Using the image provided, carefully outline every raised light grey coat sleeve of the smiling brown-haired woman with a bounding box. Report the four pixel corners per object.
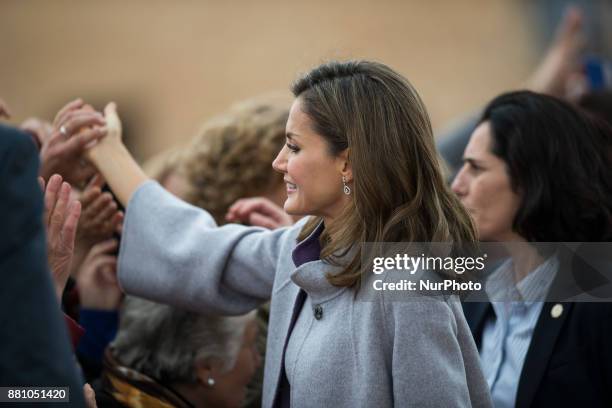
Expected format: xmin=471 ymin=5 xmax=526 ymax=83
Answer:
xmin=119 ymin=181 xmax=298 ymax=315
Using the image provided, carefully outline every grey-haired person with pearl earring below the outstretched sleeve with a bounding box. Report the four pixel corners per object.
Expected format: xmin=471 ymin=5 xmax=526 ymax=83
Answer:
xmin=96 ymin=297 xmax=261 ymax=408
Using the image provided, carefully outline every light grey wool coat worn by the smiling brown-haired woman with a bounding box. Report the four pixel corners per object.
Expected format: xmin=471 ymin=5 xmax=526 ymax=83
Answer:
xmin=119 ymin=181 xmax=491 ymax=408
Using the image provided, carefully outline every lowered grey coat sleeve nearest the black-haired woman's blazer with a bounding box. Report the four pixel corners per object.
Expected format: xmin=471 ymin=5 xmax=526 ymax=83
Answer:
xmin=385 ymin=297 xmax=491 ymax=407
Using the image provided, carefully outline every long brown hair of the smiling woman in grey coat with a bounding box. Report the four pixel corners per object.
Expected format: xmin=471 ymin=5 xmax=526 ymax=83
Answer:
xmin=292 ymin=61 xmax=477 ymax=287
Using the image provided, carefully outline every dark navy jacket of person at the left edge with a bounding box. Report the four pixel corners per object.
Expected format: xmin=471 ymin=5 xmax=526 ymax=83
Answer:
xmin=0 ymin=125 xmax=85 ymax=406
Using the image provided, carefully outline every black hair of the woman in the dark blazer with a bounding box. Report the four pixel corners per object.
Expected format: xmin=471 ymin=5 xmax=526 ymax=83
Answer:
xmin=479 ymin=91 xmax=612 ymax=242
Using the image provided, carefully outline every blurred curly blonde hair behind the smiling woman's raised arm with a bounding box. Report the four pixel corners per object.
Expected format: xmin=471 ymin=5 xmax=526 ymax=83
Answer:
xmin=177 ymin=100 xmax=289 ymax=225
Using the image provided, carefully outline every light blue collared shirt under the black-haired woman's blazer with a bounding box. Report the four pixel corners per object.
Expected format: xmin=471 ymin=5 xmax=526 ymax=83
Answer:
xmin=480 ymin=257 xmax=558 ymax=408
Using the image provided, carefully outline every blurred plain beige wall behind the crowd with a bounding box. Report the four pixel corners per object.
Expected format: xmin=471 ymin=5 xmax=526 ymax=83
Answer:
xmin=0 ymin=0 xmax=533 ymax=158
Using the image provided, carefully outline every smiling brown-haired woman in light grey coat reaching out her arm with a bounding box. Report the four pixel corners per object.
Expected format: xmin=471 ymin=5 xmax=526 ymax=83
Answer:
xmin=82 ymin=61 xmax=490 ymax=407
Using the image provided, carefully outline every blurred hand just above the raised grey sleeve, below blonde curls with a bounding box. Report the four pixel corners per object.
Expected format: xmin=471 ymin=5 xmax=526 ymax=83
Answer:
xmin=225 ymin=197 xmax=293 ymax=229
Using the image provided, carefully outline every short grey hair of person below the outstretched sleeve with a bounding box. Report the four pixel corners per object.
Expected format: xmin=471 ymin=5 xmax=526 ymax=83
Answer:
xmin=111 ymin=297 xmax=254 ymax=383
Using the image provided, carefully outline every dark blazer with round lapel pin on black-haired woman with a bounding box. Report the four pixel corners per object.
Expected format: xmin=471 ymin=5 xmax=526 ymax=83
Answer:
xmin=463 ymin=249 xmax=612 ymax=408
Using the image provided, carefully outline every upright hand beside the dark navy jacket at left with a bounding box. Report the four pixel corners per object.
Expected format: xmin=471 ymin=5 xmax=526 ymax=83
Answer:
xmin=39 ymin=174 xmax=81 ymax=299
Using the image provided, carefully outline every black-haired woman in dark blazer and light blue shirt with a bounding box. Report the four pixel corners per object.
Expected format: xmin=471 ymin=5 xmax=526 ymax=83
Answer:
xmin=452 ymin=92 xmax=612 ymax=407
